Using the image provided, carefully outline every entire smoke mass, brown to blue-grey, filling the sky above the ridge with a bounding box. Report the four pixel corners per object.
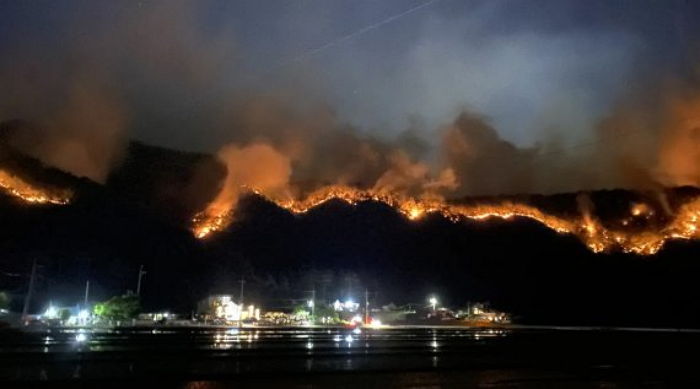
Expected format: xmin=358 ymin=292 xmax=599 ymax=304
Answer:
xmin=0 ymin=1 xmax=700 ymax=203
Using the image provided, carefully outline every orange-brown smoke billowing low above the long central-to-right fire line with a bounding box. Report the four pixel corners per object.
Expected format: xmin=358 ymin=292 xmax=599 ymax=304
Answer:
xmin=206 ymin=80 xmax=700 ymax=218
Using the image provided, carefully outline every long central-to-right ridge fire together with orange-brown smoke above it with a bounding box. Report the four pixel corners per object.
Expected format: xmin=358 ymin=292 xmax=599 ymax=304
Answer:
xmin=186 ymin=90 xmax=700 ymax=255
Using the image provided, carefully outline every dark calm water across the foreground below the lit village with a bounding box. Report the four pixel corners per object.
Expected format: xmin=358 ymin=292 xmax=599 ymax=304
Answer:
xmin=0 ymin=328 xmax=700 ymax=388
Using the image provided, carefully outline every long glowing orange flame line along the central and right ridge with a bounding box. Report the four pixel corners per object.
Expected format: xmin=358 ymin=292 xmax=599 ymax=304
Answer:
xmin=193 ymin=186 xmax=700 ymax=255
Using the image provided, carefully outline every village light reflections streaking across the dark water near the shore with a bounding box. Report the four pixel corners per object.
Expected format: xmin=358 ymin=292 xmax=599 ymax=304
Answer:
xmin=0 ymin=327 xmax=509 ymax=379
